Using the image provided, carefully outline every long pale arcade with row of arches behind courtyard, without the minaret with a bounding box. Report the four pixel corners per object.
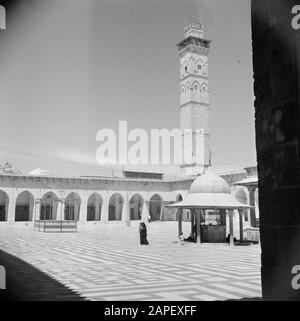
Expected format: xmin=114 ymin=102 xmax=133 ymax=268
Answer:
xmin=0 ymin=170 xmax=258 ymax=235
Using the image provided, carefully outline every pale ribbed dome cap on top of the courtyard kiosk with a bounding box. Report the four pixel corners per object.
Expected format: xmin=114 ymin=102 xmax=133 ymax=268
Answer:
xmin=190 ymin=168 xmax=231 ymax=194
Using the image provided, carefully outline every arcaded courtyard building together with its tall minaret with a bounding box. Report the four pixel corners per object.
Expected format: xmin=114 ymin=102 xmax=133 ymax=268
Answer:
xmin=0 ymin=22 xmax=257 ymax=235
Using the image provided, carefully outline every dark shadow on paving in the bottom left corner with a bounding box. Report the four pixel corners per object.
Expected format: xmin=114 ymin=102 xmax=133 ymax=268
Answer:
xmin=0 ymin=250 xmax=85 ymax=301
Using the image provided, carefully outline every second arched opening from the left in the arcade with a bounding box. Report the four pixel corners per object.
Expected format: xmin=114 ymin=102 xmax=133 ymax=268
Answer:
xmin=15 ymin=191 xmax=34 ymax=222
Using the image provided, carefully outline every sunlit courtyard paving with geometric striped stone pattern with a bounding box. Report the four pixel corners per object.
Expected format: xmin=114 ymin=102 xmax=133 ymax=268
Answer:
xmin=0 ymin=222 xmax=261 ymax=301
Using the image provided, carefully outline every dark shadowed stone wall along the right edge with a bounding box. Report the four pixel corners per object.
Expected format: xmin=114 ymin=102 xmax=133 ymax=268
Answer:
xmin=252 ymin=0 xmax=300 ymax=300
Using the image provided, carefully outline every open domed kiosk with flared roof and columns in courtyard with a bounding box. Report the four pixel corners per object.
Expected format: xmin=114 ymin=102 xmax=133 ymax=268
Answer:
xmin=169 ymin=168 xmax=251 ymax=245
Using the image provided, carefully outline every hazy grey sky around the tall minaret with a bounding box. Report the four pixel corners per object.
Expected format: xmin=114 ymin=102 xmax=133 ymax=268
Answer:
xmin=0 ymin=0 xmax=256 ymax=176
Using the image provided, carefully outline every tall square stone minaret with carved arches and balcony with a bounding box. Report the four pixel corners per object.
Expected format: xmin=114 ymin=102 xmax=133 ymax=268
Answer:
xmin=177 ymin=21 xmax=210 ymax=175
